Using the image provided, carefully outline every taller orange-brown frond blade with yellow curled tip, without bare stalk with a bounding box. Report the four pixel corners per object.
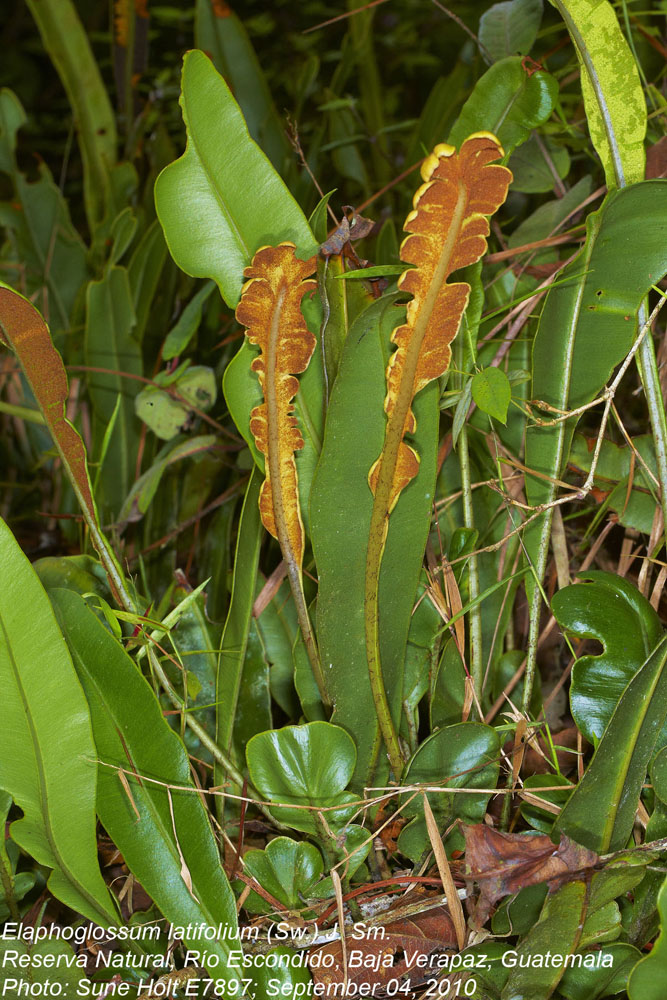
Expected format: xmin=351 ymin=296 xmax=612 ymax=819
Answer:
xmin=369 ymin=132 xmax=512 ymax=512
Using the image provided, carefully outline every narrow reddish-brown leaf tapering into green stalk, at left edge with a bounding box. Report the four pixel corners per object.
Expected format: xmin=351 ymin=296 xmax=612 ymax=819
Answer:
xmin=0 ymin=284 xmax=132 ymax=610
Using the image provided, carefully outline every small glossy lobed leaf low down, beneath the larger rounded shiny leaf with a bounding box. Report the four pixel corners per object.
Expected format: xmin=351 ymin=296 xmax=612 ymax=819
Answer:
xmin=243 ymin=837 xmax=324 ymax=913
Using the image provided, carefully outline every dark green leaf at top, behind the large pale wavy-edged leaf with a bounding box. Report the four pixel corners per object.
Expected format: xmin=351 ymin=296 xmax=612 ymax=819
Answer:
xmin=195 ymin=0 xmax=291 ymax=172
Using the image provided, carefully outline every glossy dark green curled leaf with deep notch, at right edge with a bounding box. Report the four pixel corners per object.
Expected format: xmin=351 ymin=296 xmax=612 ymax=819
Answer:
xmin=551 ymin=570 xmax=662 ymax=743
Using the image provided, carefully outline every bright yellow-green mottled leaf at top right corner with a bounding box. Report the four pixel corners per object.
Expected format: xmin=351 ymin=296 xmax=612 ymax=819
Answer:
xmin=551 ymin=0 xmax=646 ymax=189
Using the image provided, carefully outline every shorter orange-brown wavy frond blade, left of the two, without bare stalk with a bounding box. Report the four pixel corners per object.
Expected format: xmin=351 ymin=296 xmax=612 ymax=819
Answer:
xmin=236 ymin=243 xmax=317 ymax=567
